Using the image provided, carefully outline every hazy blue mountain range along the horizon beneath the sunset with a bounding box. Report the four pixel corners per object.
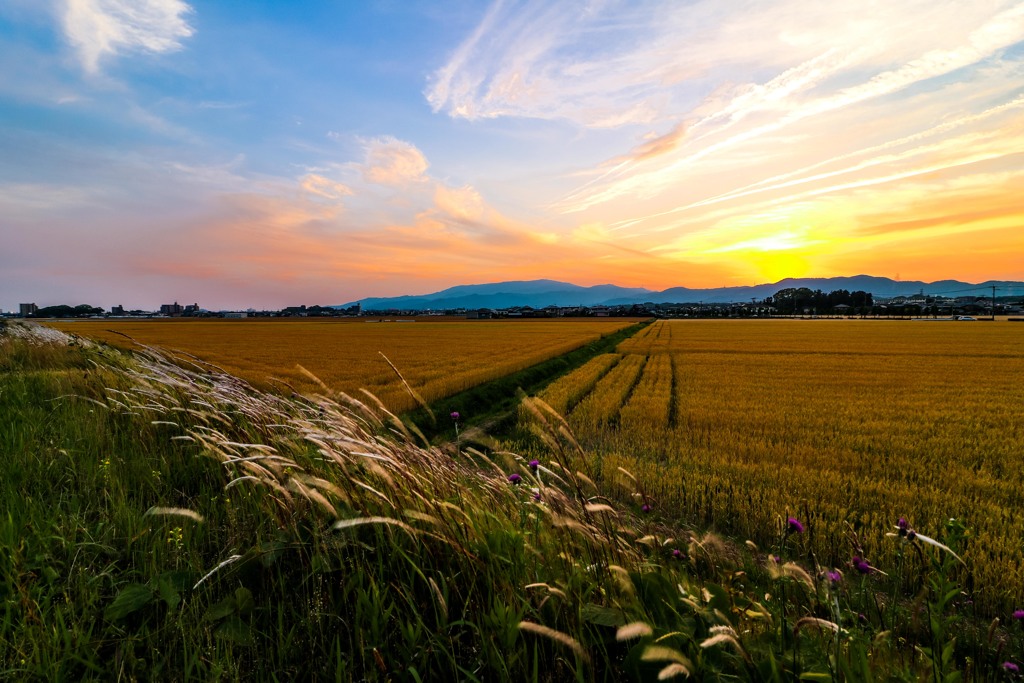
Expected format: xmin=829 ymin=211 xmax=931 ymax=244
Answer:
xmin=335 ymin=275 xmax=1024 ymax=310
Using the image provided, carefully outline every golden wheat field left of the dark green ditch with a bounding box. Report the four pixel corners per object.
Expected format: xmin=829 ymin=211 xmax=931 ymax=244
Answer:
xmin=52 ymin=318 xmax=636 ymax=412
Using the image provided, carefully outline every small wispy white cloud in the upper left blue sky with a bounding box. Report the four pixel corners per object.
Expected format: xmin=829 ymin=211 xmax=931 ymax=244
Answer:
xmin=61 ymin=0 xmax=195 ymax=74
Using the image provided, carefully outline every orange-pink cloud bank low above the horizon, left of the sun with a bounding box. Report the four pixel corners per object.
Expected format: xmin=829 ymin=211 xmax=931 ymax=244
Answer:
xmin=116 ymin=169 xmax=749 ymax=305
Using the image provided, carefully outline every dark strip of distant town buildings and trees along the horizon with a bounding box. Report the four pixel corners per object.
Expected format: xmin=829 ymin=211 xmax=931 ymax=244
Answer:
xmin=8 ymin=288 xmax=1024 ymax=319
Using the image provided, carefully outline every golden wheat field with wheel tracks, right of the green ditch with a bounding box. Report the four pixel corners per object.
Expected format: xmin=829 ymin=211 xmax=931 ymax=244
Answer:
xmin=541 ymin=321 xmax=1024 ymax=607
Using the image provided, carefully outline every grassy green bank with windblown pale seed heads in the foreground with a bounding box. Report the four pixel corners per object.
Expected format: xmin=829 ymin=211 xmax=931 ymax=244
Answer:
xmin=0 ymin=326 xmax=1024 ymax=681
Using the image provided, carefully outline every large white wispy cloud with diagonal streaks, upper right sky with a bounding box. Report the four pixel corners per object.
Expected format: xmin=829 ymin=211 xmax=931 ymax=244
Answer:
xmin=427 ymin=0 xmax=1024 ymax=224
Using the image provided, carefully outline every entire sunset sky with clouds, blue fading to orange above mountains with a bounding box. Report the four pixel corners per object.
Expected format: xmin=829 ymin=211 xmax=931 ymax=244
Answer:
xmin=0 ymin=0 xmax=1024 ymax=310
